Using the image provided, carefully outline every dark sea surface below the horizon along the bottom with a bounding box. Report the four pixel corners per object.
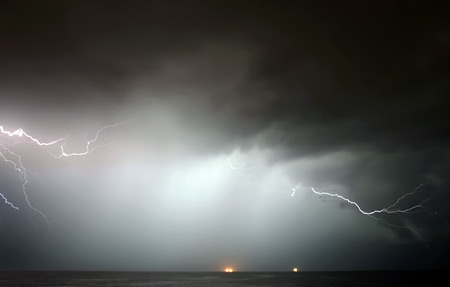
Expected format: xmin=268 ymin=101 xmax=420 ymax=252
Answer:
xmin=0 ymin=271 xmax=442 ymax=287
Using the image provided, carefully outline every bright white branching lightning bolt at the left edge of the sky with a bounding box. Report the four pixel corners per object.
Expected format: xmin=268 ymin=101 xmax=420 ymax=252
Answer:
xmin=0 ymin=120 xmax=129 ymax=226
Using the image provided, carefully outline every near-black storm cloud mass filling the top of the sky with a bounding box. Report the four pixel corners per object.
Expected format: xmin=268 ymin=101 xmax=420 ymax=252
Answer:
xmin=2 ymin=1 xmax=449 ymax=149
